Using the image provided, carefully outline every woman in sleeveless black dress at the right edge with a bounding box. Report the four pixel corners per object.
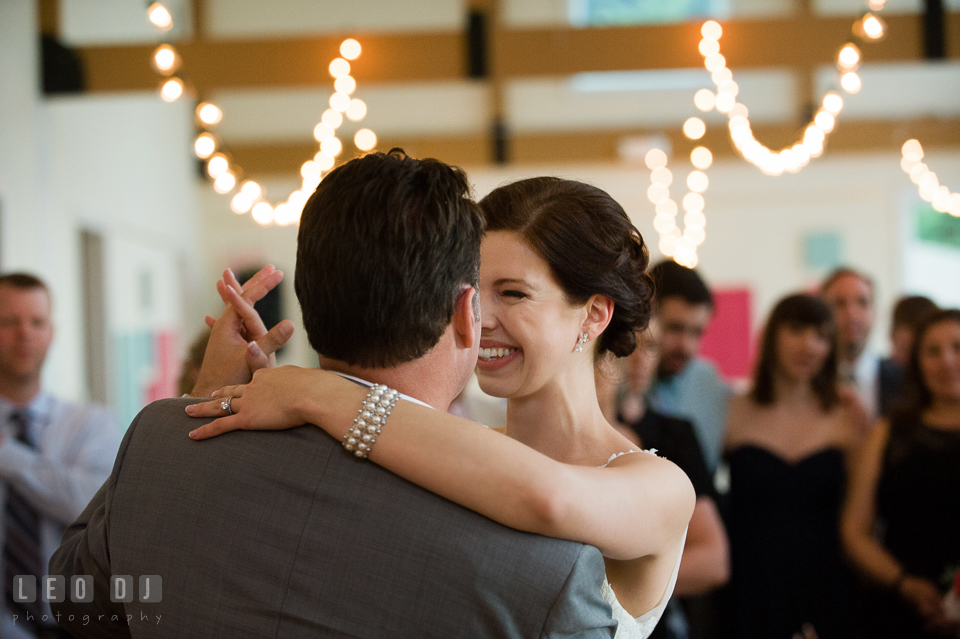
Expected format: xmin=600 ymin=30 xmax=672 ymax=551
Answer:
xmin=843 ymin=309 xmax=960 ymax=639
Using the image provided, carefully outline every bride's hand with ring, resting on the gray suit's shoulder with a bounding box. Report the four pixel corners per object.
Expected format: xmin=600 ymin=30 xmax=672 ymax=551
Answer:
xmin=186 ymin=366 xmax=324 ymax=440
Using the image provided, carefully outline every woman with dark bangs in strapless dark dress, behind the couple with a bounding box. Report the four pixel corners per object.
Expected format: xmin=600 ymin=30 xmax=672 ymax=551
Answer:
xmin=726 ymin=295 xmax=856 ymax=639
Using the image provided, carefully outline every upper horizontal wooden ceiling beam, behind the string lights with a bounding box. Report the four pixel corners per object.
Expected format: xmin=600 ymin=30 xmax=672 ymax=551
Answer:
xmin=79 ymin=12 xmax=960 ymax=94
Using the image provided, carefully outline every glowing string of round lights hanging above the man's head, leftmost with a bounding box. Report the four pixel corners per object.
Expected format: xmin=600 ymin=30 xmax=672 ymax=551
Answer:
xmin=147 ymin=2 xmax=377 ymax=226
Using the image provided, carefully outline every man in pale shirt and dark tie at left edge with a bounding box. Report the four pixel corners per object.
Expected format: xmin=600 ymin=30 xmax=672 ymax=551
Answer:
xmin=0 ymin=273 xmax=121 ymax=638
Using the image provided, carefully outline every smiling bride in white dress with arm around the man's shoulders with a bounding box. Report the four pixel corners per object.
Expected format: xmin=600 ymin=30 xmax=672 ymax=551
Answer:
xmin=187 ymin=178 xmax=694 ymax=639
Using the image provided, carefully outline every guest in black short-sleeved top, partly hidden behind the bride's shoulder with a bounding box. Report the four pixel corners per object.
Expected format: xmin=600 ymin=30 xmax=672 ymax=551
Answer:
xmin=597 ymin=318 xmax=730 ymax=639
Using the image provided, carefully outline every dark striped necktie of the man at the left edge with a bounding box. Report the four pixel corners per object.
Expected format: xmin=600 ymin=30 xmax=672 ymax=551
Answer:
xmin=3 ymin=412 xmax=44 ymax=620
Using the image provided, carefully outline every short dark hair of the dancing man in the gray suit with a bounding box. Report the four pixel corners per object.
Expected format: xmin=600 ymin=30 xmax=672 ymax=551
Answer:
xmin=294 ymin=149 xmax=484 ymax=368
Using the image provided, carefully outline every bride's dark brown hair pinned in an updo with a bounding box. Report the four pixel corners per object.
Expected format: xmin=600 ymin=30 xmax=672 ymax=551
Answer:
xmin=480 ymin=177 xmax=653 ymax=357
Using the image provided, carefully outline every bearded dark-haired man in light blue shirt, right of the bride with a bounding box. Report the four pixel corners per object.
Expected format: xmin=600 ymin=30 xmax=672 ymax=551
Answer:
xmin=647 ymin=260 xmax=730 ymax=473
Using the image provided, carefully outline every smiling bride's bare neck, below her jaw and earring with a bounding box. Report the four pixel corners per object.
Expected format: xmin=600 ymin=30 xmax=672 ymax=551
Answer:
xmin=506 ymin=370 xmax=609 ymax=461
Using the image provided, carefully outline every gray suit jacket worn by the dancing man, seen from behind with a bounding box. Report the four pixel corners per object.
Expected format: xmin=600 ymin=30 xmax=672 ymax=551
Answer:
xmin=50 ymin=400 xmax=616 ymax=639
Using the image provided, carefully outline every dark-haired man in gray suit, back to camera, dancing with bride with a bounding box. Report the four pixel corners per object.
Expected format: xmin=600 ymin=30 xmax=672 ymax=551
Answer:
xmin=50 ymin=151 xmax=616 ymax=638
